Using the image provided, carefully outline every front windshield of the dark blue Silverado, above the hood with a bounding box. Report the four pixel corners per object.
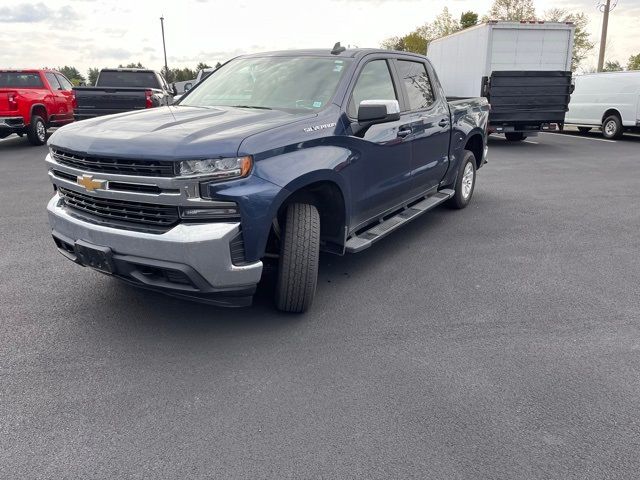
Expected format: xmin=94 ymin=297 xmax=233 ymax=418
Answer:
xmin=180 ymin=57 xmax=350 ymax=110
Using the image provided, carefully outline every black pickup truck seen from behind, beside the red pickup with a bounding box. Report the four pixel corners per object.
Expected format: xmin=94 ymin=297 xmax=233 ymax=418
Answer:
xmin=73 ymin=68 xmax=175 ymax=120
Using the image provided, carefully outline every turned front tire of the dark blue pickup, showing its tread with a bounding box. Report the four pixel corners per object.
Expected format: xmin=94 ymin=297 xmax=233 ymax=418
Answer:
xmin=276 ymin=203 xmax=320 ymax=313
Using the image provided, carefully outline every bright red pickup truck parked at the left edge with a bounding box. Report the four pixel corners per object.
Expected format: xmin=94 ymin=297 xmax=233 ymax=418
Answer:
xmin=0 ymin=70 xmax=75 ymax=145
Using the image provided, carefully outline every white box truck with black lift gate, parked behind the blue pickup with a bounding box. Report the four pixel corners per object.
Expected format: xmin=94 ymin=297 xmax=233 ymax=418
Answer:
xmin=427 ymin=21 xmax=575 ymax=141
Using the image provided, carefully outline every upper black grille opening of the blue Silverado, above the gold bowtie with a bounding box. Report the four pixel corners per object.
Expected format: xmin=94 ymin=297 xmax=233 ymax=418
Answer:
xmin=51 ymin=147 xmax=174 ymax=177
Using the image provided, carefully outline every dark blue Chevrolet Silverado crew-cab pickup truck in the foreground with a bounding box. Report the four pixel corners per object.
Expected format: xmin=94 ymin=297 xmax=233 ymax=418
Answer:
xmin=46 ymin=45 xmax=489 ymax=312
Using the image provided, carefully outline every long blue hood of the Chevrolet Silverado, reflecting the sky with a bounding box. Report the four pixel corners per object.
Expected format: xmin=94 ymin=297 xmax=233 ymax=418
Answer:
xmin=49 ymin=106 xmax=316 ymax=160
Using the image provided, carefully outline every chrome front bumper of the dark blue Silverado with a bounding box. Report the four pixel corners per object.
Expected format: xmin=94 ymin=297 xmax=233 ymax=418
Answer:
xmin=47 ymin=194 xmax=262 ymax=306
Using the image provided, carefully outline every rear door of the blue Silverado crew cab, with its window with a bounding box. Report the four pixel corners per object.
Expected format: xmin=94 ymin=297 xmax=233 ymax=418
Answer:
xmin=395 ymin=59 xmax=451 ymax=194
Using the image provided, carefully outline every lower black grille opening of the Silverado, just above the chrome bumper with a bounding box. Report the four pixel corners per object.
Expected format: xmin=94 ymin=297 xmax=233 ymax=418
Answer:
xmin=58 ymin=187 xmax=180 ymax=229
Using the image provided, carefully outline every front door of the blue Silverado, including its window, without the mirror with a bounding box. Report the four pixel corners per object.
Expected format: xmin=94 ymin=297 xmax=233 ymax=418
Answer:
xmin=347 ymin=58 xmax=411 ymax=228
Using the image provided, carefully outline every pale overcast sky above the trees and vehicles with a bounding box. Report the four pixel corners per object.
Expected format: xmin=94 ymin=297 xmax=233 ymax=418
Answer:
xmin=0 ymin=0 xmax=640 ymax=74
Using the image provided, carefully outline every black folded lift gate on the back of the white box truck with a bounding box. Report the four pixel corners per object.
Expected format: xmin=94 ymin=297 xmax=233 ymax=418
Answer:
xmin=488 ymin=71 xmax=571 ymax=123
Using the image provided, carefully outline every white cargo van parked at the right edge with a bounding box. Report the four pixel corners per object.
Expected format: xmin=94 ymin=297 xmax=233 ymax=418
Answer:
xmin=566 ymin=70 xmax=640 ymax=138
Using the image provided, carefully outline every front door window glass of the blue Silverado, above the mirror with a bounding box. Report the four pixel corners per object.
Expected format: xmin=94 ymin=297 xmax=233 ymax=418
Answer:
xmin=347 ymin=60 xmax=398 ymax=118
